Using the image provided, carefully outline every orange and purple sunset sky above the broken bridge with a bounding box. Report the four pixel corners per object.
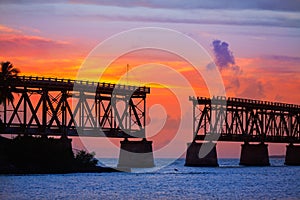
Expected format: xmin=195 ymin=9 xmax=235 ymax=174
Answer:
xmin=0 ymin=0 xmax=300 ymax=159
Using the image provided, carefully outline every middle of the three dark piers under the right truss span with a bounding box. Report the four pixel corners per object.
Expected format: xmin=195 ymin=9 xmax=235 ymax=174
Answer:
xmin=240 ymin=143 xmax=270 ymax=166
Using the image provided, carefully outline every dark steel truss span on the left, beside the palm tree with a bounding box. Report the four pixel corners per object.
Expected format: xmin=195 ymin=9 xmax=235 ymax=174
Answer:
xmin=0 ymin=76 xmax=150 ymax=138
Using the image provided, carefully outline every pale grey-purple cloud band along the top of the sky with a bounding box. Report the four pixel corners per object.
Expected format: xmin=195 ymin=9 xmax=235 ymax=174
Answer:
xmin=0 ymin=0 xmax=300 ymax=28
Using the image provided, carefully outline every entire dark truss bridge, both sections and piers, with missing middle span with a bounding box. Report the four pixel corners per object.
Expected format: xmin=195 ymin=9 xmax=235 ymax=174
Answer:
xmin=0 ymin=76 xmax=300 ymax=166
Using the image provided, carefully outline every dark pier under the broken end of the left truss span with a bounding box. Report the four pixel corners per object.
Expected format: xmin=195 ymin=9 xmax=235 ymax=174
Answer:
xmin=118 ymin=139 xmax=154 ymax=168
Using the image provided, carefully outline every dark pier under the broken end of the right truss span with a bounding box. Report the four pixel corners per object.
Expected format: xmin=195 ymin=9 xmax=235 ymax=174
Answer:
xmin=185 ymin=142 xmax=219 ymax=167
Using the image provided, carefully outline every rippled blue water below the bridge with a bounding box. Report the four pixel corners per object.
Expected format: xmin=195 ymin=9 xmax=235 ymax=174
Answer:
xmin=0 ymin=159 xmax=300 ymax=199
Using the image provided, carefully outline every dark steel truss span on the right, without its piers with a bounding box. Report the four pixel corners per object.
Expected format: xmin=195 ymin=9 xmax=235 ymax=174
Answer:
xmin=189 ymin=97 xmax=300 ymax=143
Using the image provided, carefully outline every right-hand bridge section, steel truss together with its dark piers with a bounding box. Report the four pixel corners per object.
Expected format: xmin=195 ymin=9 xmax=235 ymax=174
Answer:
xmin=186 ymin=97 xmax=300 ymax=166
